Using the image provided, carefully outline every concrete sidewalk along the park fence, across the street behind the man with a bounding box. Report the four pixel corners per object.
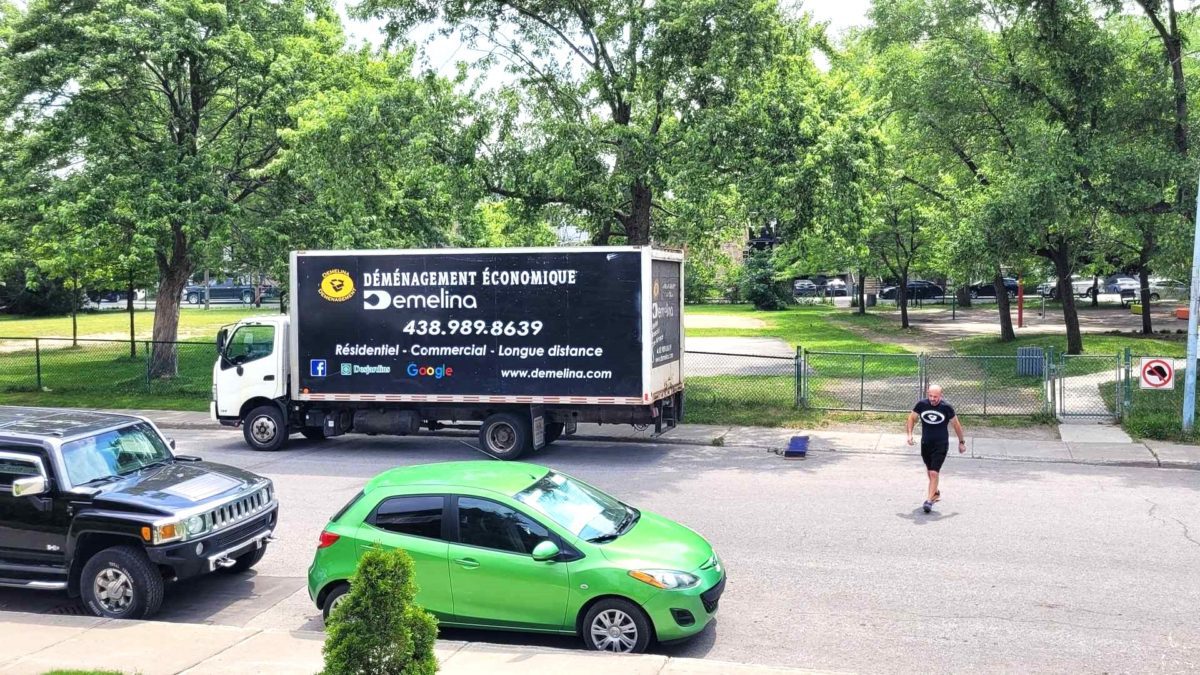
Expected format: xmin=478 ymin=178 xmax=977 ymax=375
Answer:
xmin=121 ymin=411 xmax=1200 ymax=470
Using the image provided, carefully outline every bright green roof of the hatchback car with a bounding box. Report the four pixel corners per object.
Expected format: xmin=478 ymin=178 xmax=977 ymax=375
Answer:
xmin=364 ymin=460 xmax=550 ymax=495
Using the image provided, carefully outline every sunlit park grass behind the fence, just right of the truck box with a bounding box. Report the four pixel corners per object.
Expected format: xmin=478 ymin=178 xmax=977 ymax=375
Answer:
xmin=684 ymin=300 xmax=908 ymax=354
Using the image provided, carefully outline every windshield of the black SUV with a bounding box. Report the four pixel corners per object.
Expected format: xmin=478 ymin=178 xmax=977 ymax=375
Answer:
xmin=62 ymin=423 xmax=172 ymax=485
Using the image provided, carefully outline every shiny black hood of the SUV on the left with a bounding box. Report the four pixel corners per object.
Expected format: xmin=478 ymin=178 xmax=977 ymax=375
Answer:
xmin=92 ymin=461 xmax=266 ymax=515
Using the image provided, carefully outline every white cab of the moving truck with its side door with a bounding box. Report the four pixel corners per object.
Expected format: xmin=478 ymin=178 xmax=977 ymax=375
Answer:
xmin=216 ymin=323 xmax=283 ymax=417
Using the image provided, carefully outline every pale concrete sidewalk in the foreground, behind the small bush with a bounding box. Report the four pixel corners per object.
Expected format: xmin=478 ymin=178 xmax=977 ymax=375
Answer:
xmin=0 ymin=611 xmax=812 ymax=675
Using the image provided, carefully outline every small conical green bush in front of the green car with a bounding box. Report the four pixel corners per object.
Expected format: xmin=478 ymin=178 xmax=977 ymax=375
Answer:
xmin=324 ymin=550 xmax=438 ymax=675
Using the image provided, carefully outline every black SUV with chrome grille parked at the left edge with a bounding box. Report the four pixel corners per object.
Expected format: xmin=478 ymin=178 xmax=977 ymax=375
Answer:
xmin=0 ymin=406 xmax=278 ymax=619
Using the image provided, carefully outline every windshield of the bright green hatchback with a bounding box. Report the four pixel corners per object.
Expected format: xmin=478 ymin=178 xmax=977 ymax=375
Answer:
xmin=514 ymin=471 xmax=636 ymax=539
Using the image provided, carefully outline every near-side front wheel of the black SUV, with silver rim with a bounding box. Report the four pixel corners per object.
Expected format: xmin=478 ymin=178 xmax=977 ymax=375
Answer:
xmin=79 ymin=545 xmax=163 ymax=619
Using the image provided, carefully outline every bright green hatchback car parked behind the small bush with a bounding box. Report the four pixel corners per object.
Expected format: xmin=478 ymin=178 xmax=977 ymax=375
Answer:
xmin=308 ymin=461 xmax=725 ymax=652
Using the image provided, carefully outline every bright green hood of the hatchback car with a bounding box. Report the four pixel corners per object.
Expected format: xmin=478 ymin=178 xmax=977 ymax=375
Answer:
xmin=598 ymin=510 xmax=713 ymax=572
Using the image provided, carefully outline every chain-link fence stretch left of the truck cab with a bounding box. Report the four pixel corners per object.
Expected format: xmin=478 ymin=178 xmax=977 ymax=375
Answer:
xmin=0 ymin=338 xmax=216 ymax=400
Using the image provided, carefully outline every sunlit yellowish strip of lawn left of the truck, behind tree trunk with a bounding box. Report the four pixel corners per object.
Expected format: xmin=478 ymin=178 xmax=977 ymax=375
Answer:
xmin=0 ymin=306 xmax=278 ymax=341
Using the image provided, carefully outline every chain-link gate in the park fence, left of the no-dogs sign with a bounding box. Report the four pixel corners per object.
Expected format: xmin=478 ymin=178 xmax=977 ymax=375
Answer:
xmin=1054 ymin=353 xmax=1126 ymax=419
